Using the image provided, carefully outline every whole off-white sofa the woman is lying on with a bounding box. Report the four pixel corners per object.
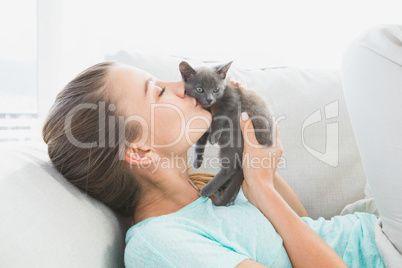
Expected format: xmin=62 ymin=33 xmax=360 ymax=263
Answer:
xmin=0 ymin=51 xmax=366 ymax=267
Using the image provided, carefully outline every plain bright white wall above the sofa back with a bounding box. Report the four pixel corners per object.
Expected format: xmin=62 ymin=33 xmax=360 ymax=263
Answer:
xmin=34 ymin=0 xmax=402 ymax=116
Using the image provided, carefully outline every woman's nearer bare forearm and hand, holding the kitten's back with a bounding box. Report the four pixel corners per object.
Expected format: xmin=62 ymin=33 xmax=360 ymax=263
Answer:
xmin=240 ymin=114 xmax=347 ymax=267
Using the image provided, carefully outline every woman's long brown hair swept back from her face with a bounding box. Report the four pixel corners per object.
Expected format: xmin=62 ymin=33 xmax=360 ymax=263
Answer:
xmin=42 ymin=62 xmax=214 ymax=217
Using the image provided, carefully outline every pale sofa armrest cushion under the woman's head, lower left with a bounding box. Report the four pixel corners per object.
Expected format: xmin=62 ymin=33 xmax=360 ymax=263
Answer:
xmin=0 ymin=144 xmax=131 ymax=267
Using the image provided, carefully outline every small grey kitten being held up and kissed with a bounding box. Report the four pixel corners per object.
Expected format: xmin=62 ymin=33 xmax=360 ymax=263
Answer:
xmin=179 ymin=61 xmax=273 ymax=206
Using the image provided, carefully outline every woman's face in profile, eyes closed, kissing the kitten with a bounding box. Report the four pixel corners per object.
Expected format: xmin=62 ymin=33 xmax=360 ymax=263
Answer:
xmin=110 ymin=65 xmax=212 ymax=156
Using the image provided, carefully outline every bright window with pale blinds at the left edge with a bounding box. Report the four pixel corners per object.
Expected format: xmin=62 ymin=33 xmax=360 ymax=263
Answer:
xmin=0 ymin=0 xmax=38 ymax=142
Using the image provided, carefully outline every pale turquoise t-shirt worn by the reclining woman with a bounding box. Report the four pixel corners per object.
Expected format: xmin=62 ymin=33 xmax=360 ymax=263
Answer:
xmin=124 ymin=191 xmax=385 ymax=268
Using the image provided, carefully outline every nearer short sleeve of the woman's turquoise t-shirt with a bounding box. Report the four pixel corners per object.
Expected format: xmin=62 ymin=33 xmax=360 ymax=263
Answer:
xmin=124 ymin=228 xmax=248 ymax=268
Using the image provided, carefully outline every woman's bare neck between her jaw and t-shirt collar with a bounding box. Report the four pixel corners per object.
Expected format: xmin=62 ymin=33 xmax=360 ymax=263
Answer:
xmin=134 ymin=153 xmax=201 ymax=224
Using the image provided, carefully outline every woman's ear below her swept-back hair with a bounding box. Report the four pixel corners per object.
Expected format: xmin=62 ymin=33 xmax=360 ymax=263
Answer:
xmin=125 ymin=143 xmax=160 ymax=166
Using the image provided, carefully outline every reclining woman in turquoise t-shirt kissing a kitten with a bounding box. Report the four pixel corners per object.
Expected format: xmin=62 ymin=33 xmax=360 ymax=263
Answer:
xmin=43 ymin=24 xmax=398 ymax=267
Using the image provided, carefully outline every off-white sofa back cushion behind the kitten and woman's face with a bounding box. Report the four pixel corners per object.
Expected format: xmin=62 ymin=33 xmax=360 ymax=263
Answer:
xmin=105 ymin=51 xmax=366 ymax=219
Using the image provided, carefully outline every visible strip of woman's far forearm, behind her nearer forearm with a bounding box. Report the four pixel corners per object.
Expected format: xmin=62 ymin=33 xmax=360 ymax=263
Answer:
xmin=274 ymin=172 xmax=308 ymax=217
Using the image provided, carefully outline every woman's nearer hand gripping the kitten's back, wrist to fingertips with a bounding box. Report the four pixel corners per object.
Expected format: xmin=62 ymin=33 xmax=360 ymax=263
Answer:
xmin=240 ymin=113 xmax=283 ymax=207
